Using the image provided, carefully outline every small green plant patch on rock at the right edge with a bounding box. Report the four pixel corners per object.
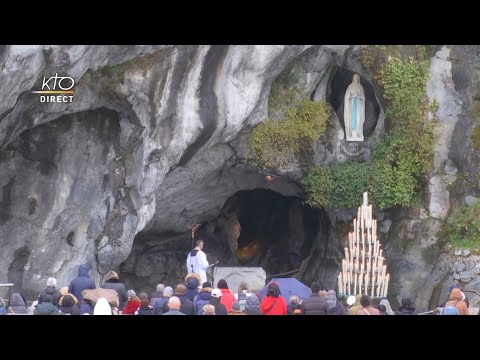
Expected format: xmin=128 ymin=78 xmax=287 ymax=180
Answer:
xmin=441 ymin=200 xmax=480 ymax=249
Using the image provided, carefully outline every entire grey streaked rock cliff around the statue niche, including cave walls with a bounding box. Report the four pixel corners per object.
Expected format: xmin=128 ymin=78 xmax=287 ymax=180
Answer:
xmin=0 ymin=45 xmax=480 ymax=309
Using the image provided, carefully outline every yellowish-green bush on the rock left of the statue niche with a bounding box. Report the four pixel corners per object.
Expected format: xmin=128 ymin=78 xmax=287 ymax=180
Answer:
xmin=248 ymin=99 xmax=331 ymax=169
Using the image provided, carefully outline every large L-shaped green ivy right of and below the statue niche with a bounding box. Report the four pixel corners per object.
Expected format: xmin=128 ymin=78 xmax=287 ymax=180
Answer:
xmin=302 ymin=46 xmax=438 ymax=208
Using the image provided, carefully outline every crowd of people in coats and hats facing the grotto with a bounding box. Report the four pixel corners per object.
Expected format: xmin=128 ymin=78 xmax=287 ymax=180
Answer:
xmin=0 ymin=266 xmax=476 ymax=315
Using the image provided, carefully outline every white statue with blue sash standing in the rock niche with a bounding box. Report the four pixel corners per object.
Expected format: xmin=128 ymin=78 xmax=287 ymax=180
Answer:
xmin=343 ymin=74 xmax=365 ymax=141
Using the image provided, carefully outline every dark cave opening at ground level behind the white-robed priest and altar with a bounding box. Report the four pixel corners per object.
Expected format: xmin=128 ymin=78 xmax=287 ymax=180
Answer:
xmin=120 ymin=188 xmax=338 ymax=291
